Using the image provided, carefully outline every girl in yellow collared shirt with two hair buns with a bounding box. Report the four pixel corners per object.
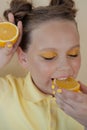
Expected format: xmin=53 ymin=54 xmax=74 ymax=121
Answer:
xmin=0 ymin=0 xmax=87 ymax=130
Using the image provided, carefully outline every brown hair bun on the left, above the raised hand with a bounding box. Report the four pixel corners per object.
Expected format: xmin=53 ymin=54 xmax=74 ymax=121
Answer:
xmin=4 ymin=0 xmax=32 ymax=23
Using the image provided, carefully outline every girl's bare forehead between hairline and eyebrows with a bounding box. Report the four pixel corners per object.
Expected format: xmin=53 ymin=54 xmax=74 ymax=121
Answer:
xmin=31 ymin=20 xmax=79 ymax=49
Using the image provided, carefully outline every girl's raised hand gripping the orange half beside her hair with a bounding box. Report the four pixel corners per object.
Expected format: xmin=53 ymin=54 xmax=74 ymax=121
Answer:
xmin=0 ymin=13 xmax=23 ymax=69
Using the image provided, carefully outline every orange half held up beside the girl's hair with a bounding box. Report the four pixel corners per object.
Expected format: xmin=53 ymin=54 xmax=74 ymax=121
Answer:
xmin=0 ymin=22 xmax=19 ymax=47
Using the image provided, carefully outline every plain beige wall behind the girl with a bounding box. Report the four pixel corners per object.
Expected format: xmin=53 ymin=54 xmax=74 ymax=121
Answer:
xmin=0 ymin=0 xmax=87 ymax=84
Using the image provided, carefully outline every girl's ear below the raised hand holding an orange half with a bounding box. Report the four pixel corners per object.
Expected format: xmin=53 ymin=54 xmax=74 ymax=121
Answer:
xmin=17 ymin=47 xmax=29 ymax=69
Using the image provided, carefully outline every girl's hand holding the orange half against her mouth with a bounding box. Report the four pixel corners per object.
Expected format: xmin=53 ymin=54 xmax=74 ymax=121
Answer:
xmin=55 ymin=82 xmax=87 ymax=127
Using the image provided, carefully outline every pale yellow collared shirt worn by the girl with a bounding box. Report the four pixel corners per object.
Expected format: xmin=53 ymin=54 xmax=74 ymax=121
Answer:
xmin=0 ymin=74 xmax=84 ymax=130
